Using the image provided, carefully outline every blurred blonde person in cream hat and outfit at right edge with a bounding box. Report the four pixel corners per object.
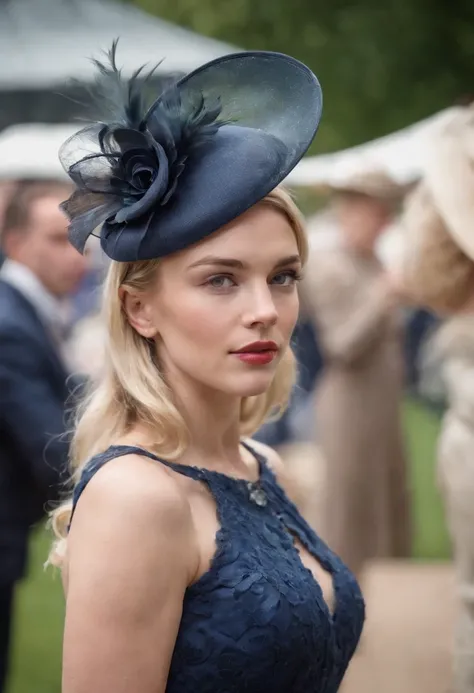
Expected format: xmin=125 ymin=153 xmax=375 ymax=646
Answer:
xmin=402 ymin=108 xmax=474 ymax=693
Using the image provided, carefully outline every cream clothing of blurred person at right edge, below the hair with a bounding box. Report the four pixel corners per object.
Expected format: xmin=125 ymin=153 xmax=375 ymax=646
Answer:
xmin=426 ymin=315 xmax=474 ymax=693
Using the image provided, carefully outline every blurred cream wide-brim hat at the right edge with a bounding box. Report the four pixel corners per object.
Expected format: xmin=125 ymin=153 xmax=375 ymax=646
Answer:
xmin=423 ymin=106 xmax=474 ymax=260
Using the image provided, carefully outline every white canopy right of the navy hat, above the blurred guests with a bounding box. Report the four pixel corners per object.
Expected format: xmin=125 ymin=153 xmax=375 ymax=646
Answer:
xmin=287 ymin=107 xmax=461 ymax=189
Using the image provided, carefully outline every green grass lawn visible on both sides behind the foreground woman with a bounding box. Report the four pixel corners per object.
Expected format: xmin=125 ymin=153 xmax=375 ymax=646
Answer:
xmin=7 ymin=402 xmax=449 ymax=693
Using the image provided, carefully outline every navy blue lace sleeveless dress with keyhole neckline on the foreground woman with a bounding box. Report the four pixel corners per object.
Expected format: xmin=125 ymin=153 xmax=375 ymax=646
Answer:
xmin=74 ymin=446 xmax=364 ymax=693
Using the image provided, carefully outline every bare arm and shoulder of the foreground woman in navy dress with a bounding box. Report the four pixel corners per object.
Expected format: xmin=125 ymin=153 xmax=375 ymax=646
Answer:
xmin=62 ymin=456 xmax=198 ymax=693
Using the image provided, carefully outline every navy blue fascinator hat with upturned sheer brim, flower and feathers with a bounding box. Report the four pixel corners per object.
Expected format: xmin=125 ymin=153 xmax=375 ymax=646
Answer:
xmin=59 ymin=43 xmax=322 ymax=262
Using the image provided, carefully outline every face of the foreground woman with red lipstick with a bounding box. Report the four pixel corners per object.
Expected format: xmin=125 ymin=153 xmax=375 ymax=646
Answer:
xmin=131 ymin=204 xmax=301 ymax=397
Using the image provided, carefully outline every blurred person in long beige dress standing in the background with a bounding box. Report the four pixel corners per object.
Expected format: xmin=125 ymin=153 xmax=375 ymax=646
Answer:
xmin=302 ymin=185 xmax=411 ymax=574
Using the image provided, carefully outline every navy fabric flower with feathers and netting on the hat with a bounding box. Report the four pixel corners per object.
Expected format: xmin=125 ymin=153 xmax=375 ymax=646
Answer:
xmin=59 ymin=42 xmax=225 ymax=252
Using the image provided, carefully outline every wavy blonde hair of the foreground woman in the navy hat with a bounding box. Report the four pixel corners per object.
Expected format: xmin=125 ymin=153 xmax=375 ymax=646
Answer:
xmin=49 ymin=188 xmax=308 ymax=566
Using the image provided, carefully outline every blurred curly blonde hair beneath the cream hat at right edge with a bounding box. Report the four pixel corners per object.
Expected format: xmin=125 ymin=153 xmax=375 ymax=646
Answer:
xmin=403 ymin=184 xmax=474 ymax=313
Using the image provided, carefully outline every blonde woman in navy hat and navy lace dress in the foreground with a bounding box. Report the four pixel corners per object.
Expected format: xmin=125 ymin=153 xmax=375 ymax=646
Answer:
xmin=52 ymin=46 xmax=364 ymax=693
